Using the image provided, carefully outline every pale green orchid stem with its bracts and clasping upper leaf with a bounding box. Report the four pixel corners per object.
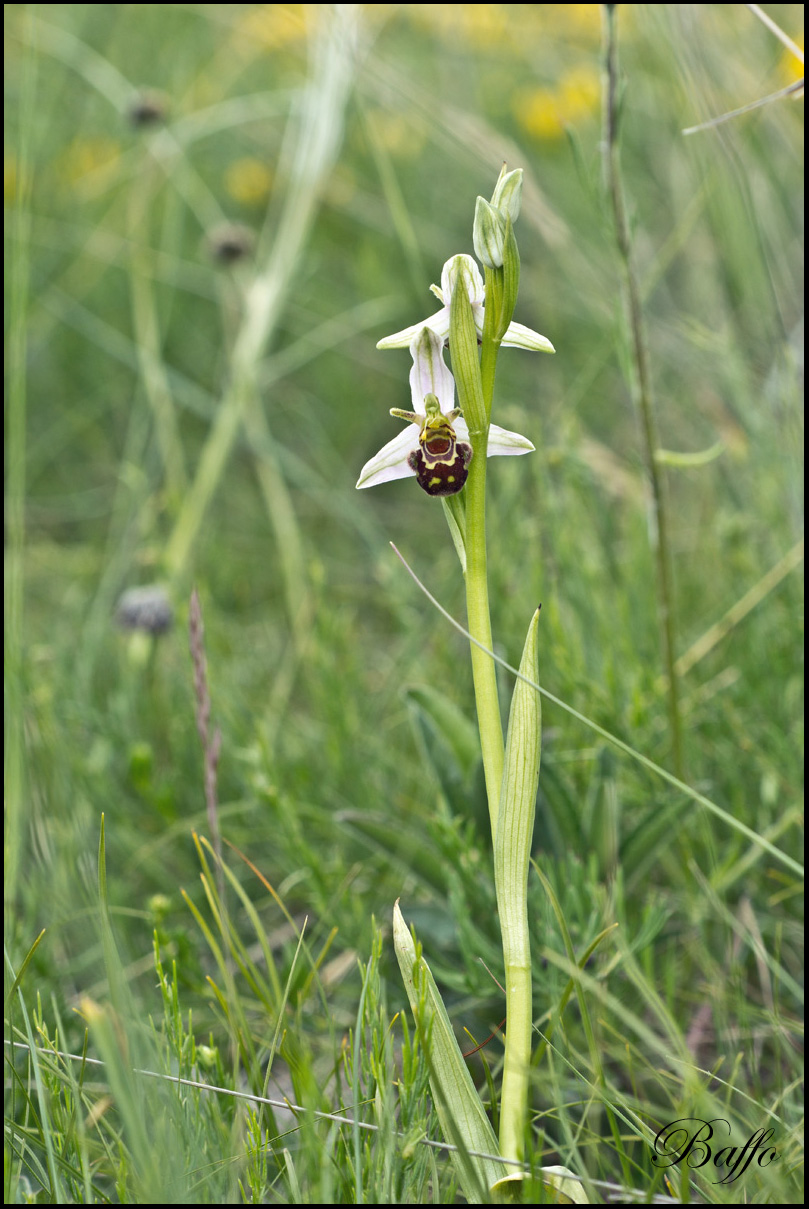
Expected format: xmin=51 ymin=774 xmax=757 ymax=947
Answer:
xmin=447 ymin=233 xmax=539 ymax=1159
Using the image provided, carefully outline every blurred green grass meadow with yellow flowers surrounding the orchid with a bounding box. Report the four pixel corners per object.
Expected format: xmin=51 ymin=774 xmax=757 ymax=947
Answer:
xmin=5 ymin=4 xmax=804 ymax=1204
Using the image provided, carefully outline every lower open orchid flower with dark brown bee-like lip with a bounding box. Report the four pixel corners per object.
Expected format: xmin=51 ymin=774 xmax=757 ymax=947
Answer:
xmin=357 ymin=328 xmax=533 ymax=496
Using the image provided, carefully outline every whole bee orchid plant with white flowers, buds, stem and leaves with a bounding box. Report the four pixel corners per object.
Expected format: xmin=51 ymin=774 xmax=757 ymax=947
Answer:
xmin=357 ymin=167 xmax=586 ymax=1203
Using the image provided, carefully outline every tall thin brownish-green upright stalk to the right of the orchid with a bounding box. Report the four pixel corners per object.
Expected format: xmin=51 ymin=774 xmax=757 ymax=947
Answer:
xmin=603 ymin=4 xmax=684 ymax=780
